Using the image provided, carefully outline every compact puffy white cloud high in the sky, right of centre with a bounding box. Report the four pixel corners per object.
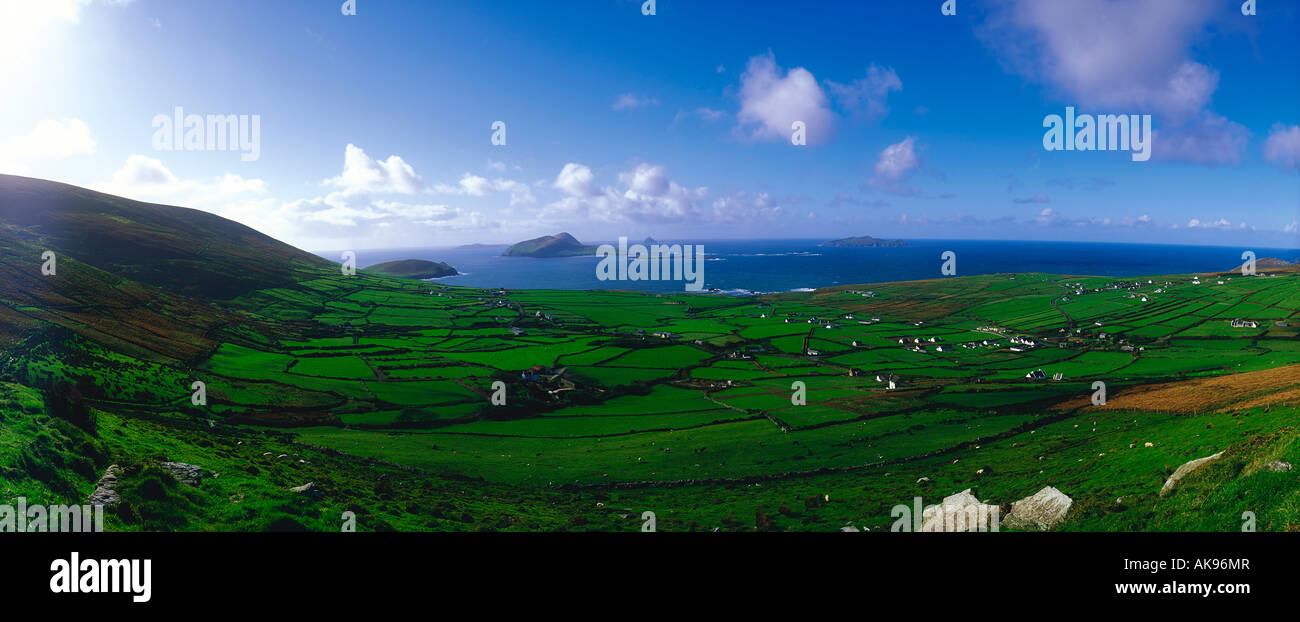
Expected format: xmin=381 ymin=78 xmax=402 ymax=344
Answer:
xmin=736 ymin=52 xmax=833 ymax=143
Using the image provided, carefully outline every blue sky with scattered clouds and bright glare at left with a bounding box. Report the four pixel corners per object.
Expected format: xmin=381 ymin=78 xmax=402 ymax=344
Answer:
xmin=0 ymin=0 xmax=1300 ymax=250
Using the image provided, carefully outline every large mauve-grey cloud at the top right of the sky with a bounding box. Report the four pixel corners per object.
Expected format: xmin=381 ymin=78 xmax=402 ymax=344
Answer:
xmin=978 ymin=0 xmax=1247 ymax=164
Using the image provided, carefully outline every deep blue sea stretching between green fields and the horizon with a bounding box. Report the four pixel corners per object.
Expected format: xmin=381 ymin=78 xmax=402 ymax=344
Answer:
xmin=320 ymin=239 xmax=1300 ymax=294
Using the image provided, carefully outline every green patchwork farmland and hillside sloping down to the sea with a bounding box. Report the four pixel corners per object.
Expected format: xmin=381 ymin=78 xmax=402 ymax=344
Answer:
xmin=0 ymin=177 xmax=1300 ymax=531
